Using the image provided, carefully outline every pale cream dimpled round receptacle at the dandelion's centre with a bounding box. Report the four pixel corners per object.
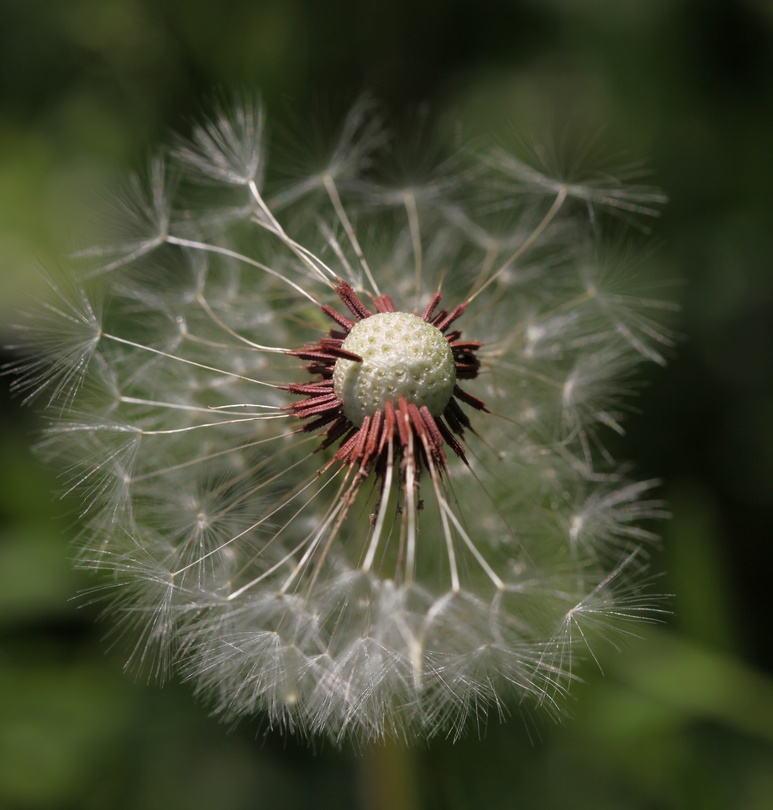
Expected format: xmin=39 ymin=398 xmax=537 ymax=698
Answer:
xmin=333 ymin=312 xmax=456 ymax=426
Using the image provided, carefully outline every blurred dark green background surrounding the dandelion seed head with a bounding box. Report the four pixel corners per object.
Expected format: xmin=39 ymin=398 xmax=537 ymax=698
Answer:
xmin=0 ymin=0 xmax=773 ymax=810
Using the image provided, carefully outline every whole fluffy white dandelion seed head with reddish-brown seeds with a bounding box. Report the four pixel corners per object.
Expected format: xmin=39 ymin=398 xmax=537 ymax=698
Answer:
xmin=10 ymin=94 xmax=669 ymax=741
